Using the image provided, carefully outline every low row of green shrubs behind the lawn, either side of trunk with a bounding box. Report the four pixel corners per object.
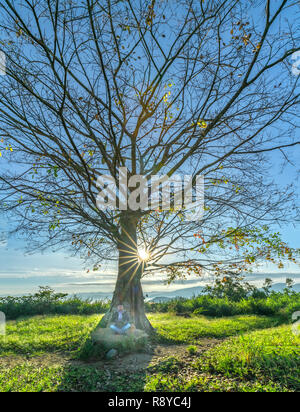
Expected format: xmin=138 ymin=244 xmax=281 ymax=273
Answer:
xmin=0 ymin=286 xmax=300 ymax=320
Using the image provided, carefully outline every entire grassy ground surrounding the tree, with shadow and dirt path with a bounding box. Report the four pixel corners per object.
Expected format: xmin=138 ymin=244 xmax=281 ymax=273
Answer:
xmin=0 ymin=313 xmax=300 ymax=392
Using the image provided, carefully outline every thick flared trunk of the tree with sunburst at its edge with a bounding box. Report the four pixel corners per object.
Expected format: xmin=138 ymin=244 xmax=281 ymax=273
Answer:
xmin=100 ymin=214 xmax=154 ymax=333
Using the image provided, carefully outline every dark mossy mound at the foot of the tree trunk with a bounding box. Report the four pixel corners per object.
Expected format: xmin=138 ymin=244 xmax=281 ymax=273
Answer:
xmin=91 ymin=327 xmax=148 ymax=352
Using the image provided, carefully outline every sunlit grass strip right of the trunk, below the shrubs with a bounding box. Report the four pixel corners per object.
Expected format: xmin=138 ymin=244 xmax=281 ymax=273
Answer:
xmin=149 ymin=313 xmax=279 ymax=343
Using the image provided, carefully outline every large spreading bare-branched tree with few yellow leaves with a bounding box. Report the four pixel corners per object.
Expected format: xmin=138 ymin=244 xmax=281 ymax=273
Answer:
xmin=0 ymin=0 xmax=300 ymax=331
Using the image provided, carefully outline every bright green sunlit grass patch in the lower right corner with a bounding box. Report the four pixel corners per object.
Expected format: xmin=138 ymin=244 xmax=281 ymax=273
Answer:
xmin=196 ymin=325 xmax=300 ymax=391
